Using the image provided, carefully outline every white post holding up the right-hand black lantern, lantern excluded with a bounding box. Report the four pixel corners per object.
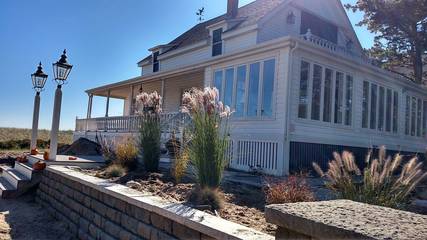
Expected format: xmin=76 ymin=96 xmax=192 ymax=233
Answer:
xmin=49 ymin=85 xmax=62 ymax=161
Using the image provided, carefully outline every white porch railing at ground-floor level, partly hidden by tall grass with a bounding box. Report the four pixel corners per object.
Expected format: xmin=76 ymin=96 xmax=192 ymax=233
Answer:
xmin=75 ymin=112 xmax=184 ymax=132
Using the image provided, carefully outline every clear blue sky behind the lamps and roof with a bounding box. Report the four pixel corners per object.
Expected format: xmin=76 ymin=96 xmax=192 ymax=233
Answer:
xmin=0 ymin=0 xmax=373 ymax=129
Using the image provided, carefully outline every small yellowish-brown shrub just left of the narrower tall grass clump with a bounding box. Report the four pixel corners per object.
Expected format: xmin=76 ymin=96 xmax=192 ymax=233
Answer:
xmin=113 ymin=138 xmax=138 ymax=169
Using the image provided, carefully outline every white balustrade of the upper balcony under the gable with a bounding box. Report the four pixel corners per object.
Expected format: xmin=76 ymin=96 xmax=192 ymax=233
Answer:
xmin=300 ymin=31 xmax=372 ymax=64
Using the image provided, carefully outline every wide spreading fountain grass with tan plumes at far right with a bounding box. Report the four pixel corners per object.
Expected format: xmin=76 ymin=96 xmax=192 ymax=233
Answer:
xmin=313 ymin=147 xmax=427 ymax=209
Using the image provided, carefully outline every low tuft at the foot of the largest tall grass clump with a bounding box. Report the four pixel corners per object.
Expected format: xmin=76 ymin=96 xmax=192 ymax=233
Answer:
xmin=189 ymin=187 xmax=224 ymax=211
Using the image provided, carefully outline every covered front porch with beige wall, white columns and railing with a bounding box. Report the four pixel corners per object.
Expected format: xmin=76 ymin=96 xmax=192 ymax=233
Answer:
xmin=75 ymin=68 xmax=205 ymax=132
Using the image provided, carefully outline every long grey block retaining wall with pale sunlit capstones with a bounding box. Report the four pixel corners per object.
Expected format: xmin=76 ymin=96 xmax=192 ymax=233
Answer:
xmin=36 ymin=166 xmax=273 ymax=240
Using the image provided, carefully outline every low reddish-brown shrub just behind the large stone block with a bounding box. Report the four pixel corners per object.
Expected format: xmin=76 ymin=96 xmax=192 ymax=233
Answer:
xmin=265 ymin=175 xmax=315 ymax=204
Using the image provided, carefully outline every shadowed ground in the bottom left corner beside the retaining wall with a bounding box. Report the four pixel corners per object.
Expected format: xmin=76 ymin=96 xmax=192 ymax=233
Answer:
xmin=0 ymin=191 xmax=74 ymax=240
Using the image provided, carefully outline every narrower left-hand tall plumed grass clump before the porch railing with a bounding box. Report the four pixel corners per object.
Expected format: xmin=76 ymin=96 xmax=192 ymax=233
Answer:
xmin=136 ymin=92 xmax=162 ymax=172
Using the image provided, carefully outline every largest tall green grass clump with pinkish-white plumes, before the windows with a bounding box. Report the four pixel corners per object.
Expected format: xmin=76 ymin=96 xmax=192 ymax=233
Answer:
xmin=182 ymin=88 xmax=231 ymax=188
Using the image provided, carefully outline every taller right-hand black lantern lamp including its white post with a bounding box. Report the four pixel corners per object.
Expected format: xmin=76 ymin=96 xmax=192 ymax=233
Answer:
xmin=49 ymin=50 xmax=73 ymax=160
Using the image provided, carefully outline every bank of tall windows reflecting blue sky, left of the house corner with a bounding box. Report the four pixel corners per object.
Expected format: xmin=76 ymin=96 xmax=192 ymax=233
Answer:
xmin=213 ymin=59 xmax=276 ymax=117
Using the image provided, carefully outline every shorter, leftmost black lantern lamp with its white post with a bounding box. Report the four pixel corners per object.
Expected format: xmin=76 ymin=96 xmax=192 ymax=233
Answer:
xmin=30 ymin=62 xmax=47 ymax=154
